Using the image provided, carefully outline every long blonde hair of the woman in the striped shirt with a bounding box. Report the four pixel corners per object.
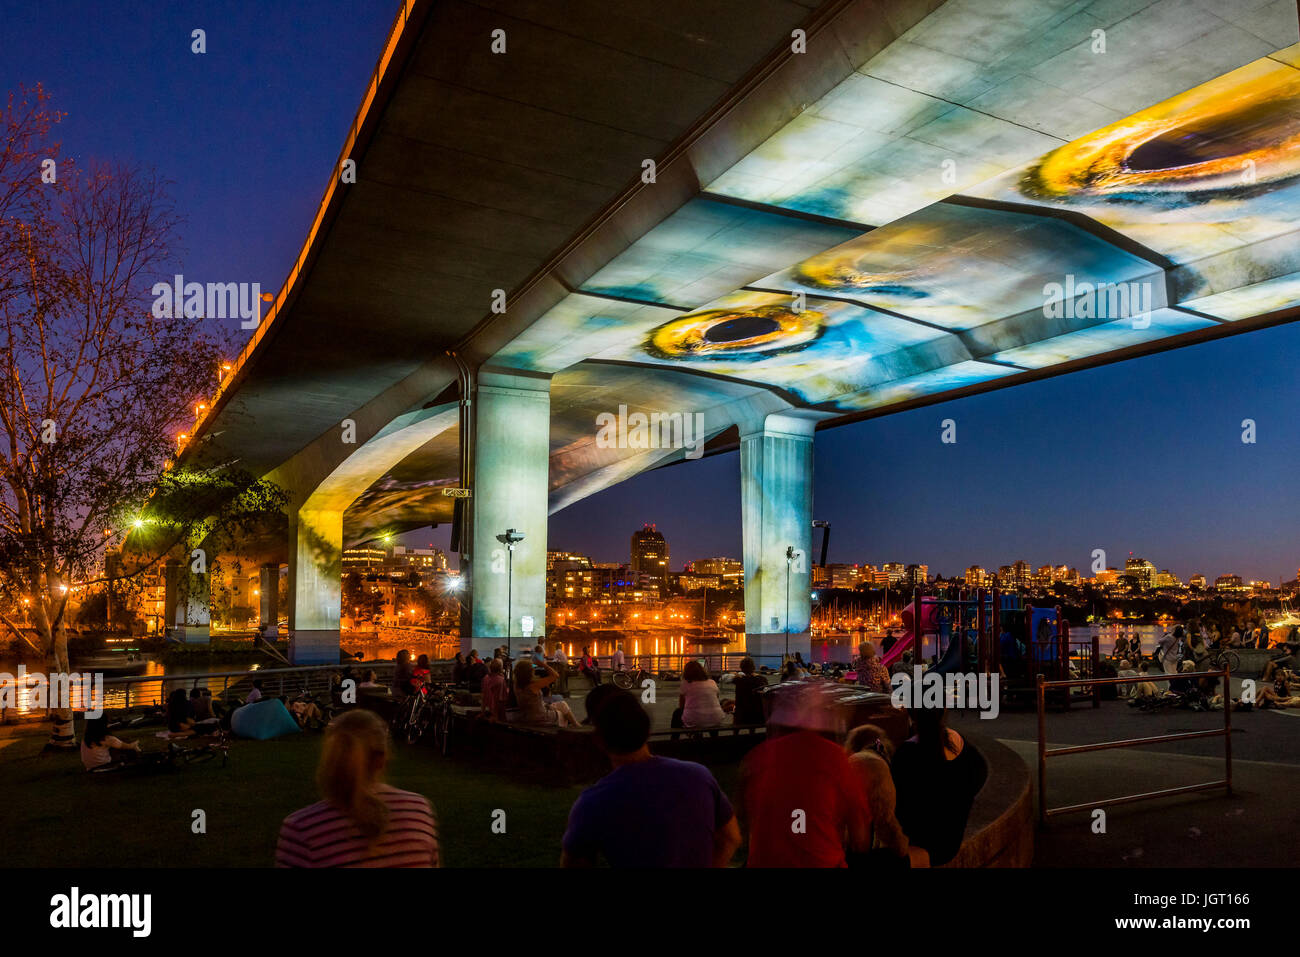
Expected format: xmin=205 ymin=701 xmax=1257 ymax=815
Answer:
xmin=316 ymin=709 xmax=389 ymax=840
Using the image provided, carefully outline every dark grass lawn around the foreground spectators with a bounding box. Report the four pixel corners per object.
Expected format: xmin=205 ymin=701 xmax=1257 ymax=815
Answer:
xmin=0 ymin=726 xmax=736 ymax=867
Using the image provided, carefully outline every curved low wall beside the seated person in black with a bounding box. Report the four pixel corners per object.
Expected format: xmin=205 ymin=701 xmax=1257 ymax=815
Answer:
xmin=944 ymin=731 xmax=1034 ymax=867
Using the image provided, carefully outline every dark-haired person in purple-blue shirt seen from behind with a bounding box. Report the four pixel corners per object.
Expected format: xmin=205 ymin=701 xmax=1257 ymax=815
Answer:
xmin=560 ymin=689 xmax=741 ymax=867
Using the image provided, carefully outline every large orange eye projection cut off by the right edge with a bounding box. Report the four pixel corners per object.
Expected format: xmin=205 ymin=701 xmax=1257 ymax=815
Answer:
xmin=1021 ymin=69 xmax=1300 ymax=207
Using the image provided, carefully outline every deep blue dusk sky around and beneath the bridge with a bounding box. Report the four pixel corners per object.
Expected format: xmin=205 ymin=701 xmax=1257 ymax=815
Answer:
xmin=12 ymin=0 xmax=1300 ymax=583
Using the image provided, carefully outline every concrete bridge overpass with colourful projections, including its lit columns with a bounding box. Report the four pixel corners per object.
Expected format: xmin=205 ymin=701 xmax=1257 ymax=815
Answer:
xmin=159 ymin=0 xmax=1300 ymax=663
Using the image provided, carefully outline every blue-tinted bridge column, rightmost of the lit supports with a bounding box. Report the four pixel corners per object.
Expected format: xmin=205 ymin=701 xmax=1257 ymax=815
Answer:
xmin=740 ymin=413 xmax=815 ymax=666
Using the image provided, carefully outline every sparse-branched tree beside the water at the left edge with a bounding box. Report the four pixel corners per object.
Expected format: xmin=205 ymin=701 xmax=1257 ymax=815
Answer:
xmin=0 ymin=87 xmax=220 ymax=746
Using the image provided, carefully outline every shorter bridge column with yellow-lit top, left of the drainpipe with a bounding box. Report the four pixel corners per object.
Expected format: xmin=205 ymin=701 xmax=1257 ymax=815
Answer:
xmin=287 ymin=508 xmax=343 ymax=664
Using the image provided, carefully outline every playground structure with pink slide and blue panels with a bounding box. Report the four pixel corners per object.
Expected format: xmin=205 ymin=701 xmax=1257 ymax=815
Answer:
xmin=881 ymin=588 xmax=1100 ymax=707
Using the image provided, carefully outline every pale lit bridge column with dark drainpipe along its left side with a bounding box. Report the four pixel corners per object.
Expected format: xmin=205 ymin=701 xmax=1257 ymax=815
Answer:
xmin=460 ymin=371 xmax=551 ymax=658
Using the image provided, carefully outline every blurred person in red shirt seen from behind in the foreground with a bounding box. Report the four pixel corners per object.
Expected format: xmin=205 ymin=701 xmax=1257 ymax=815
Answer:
xmin=736 ymin=681 xmax=871 ymax=867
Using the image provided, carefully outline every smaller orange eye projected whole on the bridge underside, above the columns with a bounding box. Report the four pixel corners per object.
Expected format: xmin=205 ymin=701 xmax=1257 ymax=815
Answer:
xmin=646 ymin=306 xmax=826 ymax=359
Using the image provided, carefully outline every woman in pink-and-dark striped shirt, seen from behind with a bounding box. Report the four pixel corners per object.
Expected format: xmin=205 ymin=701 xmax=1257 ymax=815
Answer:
xmin=276 ymin=709 xmax=438 ymax=867
